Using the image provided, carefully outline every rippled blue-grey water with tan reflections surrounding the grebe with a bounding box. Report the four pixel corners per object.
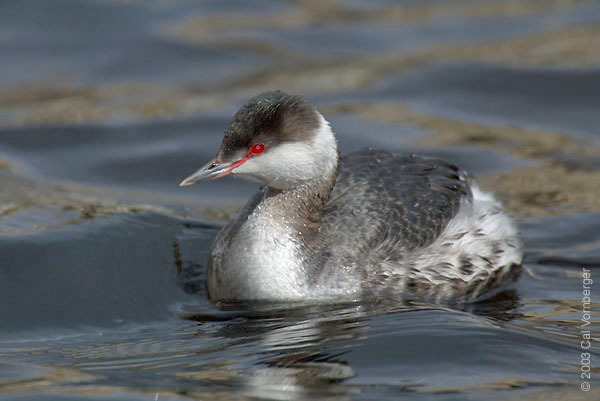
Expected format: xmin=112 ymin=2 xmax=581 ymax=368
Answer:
xmin=0 ymin=0 xmax=600 ymax=401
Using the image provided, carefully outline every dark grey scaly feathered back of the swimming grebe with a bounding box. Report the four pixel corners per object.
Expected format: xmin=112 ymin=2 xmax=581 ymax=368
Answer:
xmin=322 ymin=149 xmax=471 ymax=256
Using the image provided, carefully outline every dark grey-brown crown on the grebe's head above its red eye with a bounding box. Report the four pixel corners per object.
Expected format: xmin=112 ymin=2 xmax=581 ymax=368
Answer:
xmin=219 ymin=91 xmax=320 ymax=160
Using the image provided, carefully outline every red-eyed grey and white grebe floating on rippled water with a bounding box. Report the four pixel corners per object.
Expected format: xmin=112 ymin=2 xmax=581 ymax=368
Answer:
xmin=180 ymin=91 xmax=522 ymax=301
